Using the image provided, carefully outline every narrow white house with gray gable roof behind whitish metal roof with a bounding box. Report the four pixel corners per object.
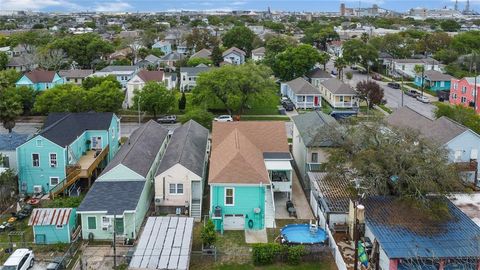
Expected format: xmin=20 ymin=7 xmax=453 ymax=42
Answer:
xmin=155 ymin=120 xmax=206 ymax=220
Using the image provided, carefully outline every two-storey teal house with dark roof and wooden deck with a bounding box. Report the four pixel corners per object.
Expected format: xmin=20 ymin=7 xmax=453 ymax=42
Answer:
xmin=16 ymin=112 xmax=120 ymax=197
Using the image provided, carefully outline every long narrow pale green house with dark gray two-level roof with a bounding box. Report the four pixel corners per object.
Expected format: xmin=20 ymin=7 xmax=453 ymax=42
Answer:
xmin=77 ymin=121 xmax=168 ymax=240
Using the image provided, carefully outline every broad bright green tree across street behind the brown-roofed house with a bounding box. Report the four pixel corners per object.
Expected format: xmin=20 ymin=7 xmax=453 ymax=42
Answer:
xmin=193 ymin=63 xmax=276 ymax=114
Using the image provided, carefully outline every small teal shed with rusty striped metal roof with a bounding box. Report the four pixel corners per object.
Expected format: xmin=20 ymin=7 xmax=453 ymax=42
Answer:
xmin=28 ymin=208 xmax=80 ymax=244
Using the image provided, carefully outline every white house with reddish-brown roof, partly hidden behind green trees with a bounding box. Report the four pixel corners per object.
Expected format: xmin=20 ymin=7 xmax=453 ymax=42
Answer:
xmin=125 ymin=69 xmax=170 ymax=107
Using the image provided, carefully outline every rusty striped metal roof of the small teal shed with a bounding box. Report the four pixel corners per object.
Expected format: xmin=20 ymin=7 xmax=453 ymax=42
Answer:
xmin=28 ymin=208 xmax=72 ymax=226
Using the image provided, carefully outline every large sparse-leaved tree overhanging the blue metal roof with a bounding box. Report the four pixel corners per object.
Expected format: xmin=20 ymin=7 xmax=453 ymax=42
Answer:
xmin=323 ymin=122 xmax=465 ymax=218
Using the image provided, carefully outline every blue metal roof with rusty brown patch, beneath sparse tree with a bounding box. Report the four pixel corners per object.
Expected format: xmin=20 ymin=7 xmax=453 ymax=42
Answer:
xmin=365 ymin=197 xmax=480 ymax=259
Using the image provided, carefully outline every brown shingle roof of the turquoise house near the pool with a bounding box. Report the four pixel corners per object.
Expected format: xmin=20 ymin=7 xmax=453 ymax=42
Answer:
xmin=208 ymin=121 xmax=289 ymax=184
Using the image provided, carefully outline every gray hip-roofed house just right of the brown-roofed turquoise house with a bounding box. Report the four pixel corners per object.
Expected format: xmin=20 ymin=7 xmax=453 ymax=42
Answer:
xmin=292 ymin=110 xmax=339 ymax=181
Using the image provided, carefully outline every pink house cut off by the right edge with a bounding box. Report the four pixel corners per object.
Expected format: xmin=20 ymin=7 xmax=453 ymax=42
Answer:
xmin=450 ymin=76 xmax=480 ymax=113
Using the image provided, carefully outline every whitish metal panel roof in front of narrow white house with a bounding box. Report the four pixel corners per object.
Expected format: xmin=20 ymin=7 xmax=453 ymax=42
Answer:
xmin=129 ymin=217 xmax=193 ymax=270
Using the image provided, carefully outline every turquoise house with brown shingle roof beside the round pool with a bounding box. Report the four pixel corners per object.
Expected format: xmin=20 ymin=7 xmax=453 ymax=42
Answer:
xmin=208 ymin=121 xmax=292 ymax=232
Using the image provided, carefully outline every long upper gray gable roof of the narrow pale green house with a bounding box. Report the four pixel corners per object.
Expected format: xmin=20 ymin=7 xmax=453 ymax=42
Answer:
xmin=99 ymin=120 xmax=168 ymax=179
